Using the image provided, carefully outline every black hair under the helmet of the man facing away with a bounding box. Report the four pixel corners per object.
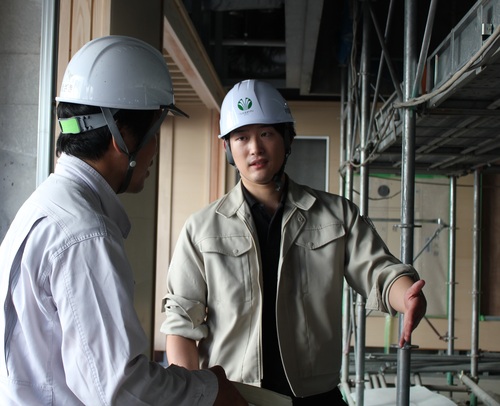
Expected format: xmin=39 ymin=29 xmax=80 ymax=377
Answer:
xmin=56 ymin=102 xmax=156 ymax=161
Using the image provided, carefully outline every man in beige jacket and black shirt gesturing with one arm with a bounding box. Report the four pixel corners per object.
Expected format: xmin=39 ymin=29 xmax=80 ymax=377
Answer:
xmin=162 ymin=80 xmax=426 ymax=406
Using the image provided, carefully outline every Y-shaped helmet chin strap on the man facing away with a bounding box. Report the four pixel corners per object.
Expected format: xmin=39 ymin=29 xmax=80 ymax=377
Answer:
xmin=101 ymin=107 xmax=169 ymax=194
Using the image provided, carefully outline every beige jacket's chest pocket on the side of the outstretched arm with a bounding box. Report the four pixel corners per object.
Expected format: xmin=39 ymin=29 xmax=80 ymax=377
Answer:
xmin=292 ymin=223 xmax=345 ymax=293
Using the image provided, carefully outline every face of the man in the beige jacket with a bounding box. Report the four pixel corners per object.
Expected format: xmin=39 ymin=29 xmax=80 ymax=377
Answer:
xmin=228 ymin=124 xmax=285 ymax=187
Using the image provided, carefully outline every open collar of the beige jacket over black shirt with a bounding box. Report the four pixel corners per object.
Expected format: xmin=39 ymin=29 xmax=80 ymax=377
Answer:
xmin=216 ymin=178 xmax=316 ymax=217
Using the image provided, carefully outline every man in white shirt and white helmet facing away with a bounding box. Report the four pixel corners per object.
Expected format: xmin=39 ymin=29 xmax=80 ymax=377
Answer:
xmin=0 ymin=36 xmax=247 ymax=406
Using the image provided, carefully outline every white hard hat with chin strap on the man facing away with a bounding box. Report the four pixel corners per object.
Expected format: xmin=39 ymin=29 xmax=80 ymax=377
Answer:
xmin=56 ymin=35 xmax=187 ymax=193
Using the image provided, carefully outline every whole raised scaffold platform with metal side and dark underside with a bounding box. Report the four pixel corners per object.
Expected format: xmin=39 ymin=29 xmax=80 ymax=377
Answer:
xmin=370 ymin=0 xmax=500 ymax=176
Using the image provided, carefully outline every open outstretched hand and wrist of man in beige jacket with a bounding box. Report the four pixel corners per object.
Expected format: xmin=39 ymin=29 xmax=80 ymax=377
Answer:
xmin=389 ymin=276 xmax=427 ymax=347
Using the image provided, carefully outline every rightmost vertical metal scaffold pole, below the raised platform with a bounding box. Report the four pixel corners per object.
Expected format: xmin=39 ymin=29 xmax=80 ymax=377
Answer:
xmin=470 ymin=169 xmax=481 ymax=379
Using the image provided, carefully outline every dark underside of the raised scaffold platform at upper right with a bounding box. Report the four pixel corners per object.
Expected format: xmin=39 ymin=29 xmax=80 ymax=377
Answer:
xmin=370 ymin=37 xmax=500 ymax=176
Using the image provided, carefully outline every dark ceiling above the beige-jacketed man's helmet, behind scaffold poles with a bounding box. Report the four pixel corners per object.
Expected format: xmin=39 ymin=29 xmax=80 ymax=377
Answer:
xmin=183 ymin=0 xmax=475 ymax=99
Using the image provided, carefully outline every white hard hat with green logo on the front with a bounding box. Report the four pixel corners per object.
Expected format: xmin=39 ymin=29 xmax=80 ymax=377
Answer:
xmin=219 ymin=79 xmax=294 ymax=138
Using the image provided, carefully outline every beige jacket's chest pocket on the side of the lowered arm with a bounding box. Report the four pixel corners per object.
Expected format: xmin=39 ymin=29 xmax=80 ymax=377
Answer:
xmin=198 ymin=236 xmax=254 ymax=305
